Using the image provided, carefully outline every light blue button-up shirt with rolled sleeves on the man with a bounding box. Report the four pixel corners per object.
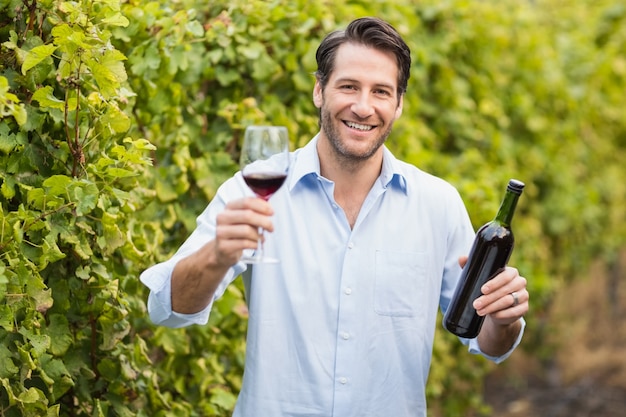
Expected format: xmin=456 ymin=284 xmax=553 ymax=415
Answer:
xmin=141 ymin=137 xmax=523 ymax=417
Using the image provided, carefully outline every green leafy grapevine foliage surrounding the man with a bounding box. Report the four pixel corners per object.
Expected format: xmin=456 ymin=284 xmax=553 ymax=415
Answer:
xmin=0 ymin=0 xmax=626 ymax=416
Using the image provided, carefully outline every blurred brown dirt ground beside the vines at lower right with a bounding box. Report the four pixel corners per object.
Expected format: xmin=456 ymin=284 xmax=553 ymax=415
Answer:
xmin=485 ymin=253 xmax=626 ymax=417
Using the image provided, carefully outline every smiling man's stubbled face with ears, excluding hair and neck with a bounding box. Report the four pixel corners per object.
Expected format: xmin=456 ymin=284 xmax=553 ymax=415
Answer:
xmin=313 ymin=43 xmax=402 ymax=161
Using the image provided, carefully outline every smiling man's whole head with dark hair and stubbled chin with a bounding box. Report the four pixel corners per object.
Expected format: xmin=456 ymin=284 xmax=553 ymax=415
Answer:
xmin=313 ymin=18 xmax=411 ymax=167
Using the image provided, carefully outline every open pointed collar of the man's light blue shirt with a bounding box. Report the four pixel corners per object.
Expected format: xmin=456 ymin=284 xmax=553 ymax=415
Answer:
xmin=289 ymin=133 xmax=407 ymax=193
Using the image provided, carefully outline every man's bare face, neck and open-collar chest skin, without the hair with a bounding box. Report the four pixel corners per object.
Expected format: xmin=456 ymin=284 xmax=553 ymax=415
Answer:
xmin=313 ymin=38 xmax=410 ymax=227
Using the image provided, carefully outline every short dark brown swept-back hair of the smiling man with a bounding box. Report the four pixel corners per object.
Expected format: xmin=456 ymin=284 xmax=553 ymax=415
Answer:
xmin=315 ymin=17 xmax=411 ymax=96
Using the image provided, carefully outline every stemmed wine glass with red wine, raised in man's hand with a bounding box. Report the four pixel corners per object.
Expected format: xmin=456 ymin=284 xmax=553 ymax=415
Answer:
xmin=240 ymin=126 xmax=289 ymax=264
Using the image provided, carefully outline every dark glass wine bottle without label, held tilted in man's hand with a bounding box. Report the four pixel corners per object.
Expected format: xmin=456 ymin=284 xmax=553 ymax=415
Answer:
xmin=443 ymin=179 xmax=524 ymax=339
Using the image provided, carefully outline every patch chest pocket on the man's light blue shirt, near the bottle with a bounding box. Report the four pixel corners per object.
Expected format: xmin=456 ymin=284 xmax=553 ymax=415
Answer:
xmin=374 ymin=251 xmax=427 ymax=317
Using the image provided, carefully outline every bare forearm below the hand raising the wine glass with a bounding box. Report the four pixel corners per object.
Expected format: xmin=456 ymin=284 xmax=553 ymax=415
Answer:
xmin=172 ymin=241 xmax=229 ymax=314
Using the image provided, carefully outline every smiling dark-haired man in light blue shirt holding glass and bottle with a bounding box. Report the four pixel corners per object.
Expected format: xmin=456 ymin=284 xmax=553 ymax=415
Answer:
xmin=141 ymin=18 xmax=528 ymax=417
